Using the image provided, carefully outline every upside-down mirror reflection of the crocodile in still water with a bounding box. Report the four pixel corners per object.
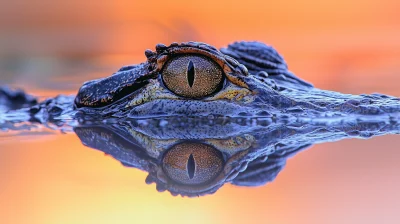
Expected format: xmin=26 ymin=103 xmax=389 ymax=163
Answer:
xmin=74 ymin=117 xmax=400 ymax=197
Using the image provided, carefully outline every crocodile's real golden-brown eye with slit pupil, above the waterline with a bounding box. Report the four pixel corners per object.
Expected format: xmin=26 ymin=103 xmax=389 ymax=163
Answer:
xmin=161 ymin=55 xmax=224 ymax=98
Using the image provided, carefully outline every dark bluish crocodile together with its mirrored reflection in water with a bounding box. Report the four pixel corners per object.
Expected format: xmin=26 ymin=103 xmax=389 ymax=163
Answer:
xmin=0 ymin=42 xmax=400 ymax=196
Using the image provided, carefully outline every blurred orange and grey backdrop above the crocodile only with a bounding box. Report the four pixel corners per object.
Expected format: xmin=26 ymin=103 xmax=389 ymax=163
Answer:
xmin=0 ymin=0 xmax=400 ymax=95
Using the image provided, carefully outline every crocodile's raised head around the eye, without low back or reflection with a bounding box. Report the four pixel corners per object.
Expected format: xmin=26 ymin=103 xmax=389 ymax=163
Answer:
xmin=75 ymin=42 xmax=312 ymax=117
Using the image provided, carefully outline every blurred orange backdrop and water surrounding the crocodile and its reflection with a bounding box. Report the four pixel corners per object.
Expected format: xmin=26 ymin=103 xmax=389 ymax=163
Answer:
xmin=0 ymin=0 xmax=400 ymax=224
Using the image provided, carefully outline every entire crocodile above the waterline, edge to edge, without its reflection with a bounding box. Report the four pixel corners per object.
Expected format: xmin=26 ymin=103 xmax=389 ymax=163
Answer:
xmin=0 ymin=42 xmax=400 ymax=123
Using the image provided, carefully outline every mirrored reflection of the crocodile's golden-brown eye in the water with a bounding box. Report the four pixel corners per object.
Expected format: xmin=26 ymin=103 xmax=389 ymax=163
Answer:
xmin=162 ymin=142 xmax=223 ymax=185
